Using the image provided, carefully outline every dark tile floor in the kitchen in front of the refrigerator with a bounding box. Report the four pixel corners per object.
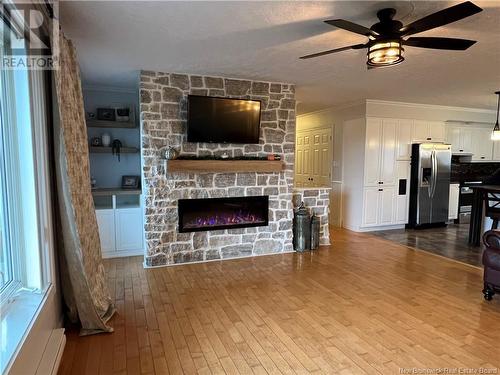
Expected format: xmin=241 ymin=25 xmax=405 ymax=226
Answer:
xmin=371 ymin=224 xmax=483 ymax=266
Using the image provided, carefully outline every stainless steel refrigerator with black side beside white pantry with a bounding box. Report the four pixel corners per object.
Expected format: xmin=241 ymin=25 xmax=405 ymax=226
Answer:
xmin=408 ymin=143 xmax=451 ymax=228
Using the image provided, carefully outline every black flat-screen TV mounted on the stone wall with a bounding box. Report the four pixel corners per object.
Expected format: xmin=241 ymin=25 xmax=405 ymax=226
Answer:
xmin=187 ymin=95 xmax=260 ymax=143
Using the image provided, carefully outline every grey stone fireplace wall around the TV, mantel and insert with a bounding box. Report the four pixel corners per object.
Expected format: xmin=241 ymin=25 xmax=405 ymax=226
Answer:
xmin=140 ymin=71 xmax=295 ymax=266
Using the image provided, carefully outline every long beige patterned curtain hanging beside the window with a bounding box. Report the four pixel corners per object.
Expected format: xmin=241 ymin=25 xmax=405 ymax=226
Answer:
xmin=54 ymin=33 xmax=115 ymax=335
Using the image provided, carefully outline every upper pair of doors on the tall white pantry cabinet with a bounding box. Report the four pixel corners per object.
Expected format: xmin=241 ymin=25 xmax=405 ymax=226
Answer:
xmin=364 ymin=118 xmax=397 ymax=186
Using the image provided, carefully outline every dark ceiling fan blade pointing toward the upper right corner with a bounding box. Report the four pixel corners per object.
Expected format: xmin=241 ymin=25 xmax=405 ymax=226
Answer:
xmin=400 ymin=1 xmax=482 ymax=36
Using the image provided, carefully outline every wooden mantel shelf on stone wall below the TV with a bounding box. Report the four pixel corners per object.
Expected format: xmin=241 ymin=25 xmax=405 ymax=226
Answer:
xmin=167 ymin=159 xmax=285 ymax=173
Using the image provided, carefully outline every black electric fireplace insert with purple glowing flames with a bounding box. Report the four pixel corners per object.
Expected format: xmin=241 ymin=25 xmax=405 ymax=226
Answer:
xmin=178 ymin=196 xmax=269 ymax=233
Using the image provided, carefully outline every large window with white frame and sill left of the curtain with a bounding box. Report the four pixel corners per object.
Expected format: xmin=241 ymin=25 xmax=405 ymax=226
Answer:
xmin=0 ymin=13 xmax=53 ymax=373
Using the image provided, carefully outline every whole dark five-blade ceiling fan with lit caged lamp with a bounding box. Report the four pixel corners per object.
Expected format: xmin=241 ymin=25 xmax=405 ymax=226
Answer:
xmin=300 ymin=1 xmax=482 ymax=69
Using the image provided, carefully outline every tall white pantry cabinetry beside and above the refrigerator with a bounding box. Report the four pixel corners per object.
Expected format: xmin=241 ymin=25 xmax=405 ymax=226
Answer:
xmin=343 ymin=117 xmax=446 ymax=231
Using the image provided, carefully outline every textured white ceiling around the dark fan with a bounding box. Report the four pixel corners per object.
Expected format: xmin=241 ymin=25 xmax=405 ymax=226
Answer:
xmin=60 ymin=1 xmax=500 ymax=113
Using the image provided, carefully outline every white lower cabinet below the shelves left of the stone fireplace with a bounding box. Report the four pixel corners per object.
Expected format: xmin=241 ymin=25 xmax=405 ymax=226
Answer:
xmin=94 ymin=195 xmax=144 ymax=258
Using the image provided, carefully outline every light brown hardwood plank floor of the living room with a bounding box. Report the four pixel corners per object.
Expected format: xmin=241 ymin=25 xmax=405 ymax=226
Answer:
xmin=59 ymin=230 xmax=500 ymax=374
